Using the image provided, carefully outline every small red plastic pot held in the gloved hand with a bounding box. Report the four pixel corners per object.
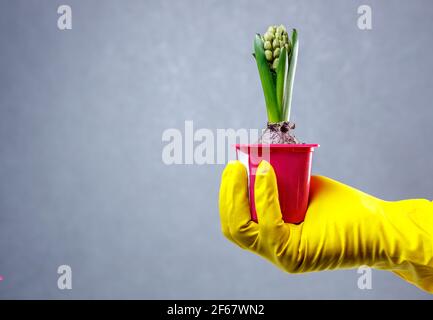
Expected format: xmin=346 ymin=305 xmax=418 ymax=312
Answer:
xmin=235 ymin=144 xmax=319 ymax=223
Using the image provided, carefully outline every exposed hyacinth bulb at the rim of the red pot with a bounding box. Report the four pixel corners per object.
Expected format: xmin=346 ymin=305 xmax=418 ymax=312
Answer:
xmin=259 ymin=121 xmax=300 ymax=144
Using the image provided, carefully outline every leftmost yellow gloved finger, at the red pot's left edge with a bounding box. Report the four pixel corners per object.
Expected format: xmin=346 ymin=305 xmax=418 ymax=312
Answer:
xmin=220 ymin=161 xmax=258 ymax=248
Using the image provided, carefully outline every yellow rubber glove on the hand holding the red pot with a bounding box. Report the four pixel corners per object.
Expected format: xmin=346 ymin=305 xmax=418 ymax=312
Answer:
xmin=219 ymin=161 xmax=433 ymax=293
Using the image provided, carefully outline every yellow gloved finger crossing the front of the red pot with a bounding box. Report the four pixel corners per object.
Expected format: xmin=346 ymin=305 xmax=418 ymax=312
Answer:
xmin=254 ymin=160 xmax=286 ymax=240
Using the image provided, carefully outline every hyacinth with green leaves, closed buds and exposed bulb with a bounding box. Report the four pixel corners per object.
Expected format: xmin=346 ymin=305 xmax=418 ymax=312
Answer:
xmin=253 ymin=25 xmax=298 ymax=143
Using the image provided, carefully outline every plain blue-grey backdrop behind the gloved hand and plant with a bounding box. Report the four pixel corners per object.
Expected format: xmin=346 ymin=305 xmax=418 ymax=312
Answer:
xmin=0 ymin=0 xmax=433 ymax=299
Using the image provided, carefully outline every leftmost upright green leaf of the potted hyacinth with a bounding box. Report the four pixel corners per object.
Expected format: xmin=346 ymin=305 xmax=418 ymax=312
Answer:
xmin=254 ymin=34 xmax=281 ymax=122
